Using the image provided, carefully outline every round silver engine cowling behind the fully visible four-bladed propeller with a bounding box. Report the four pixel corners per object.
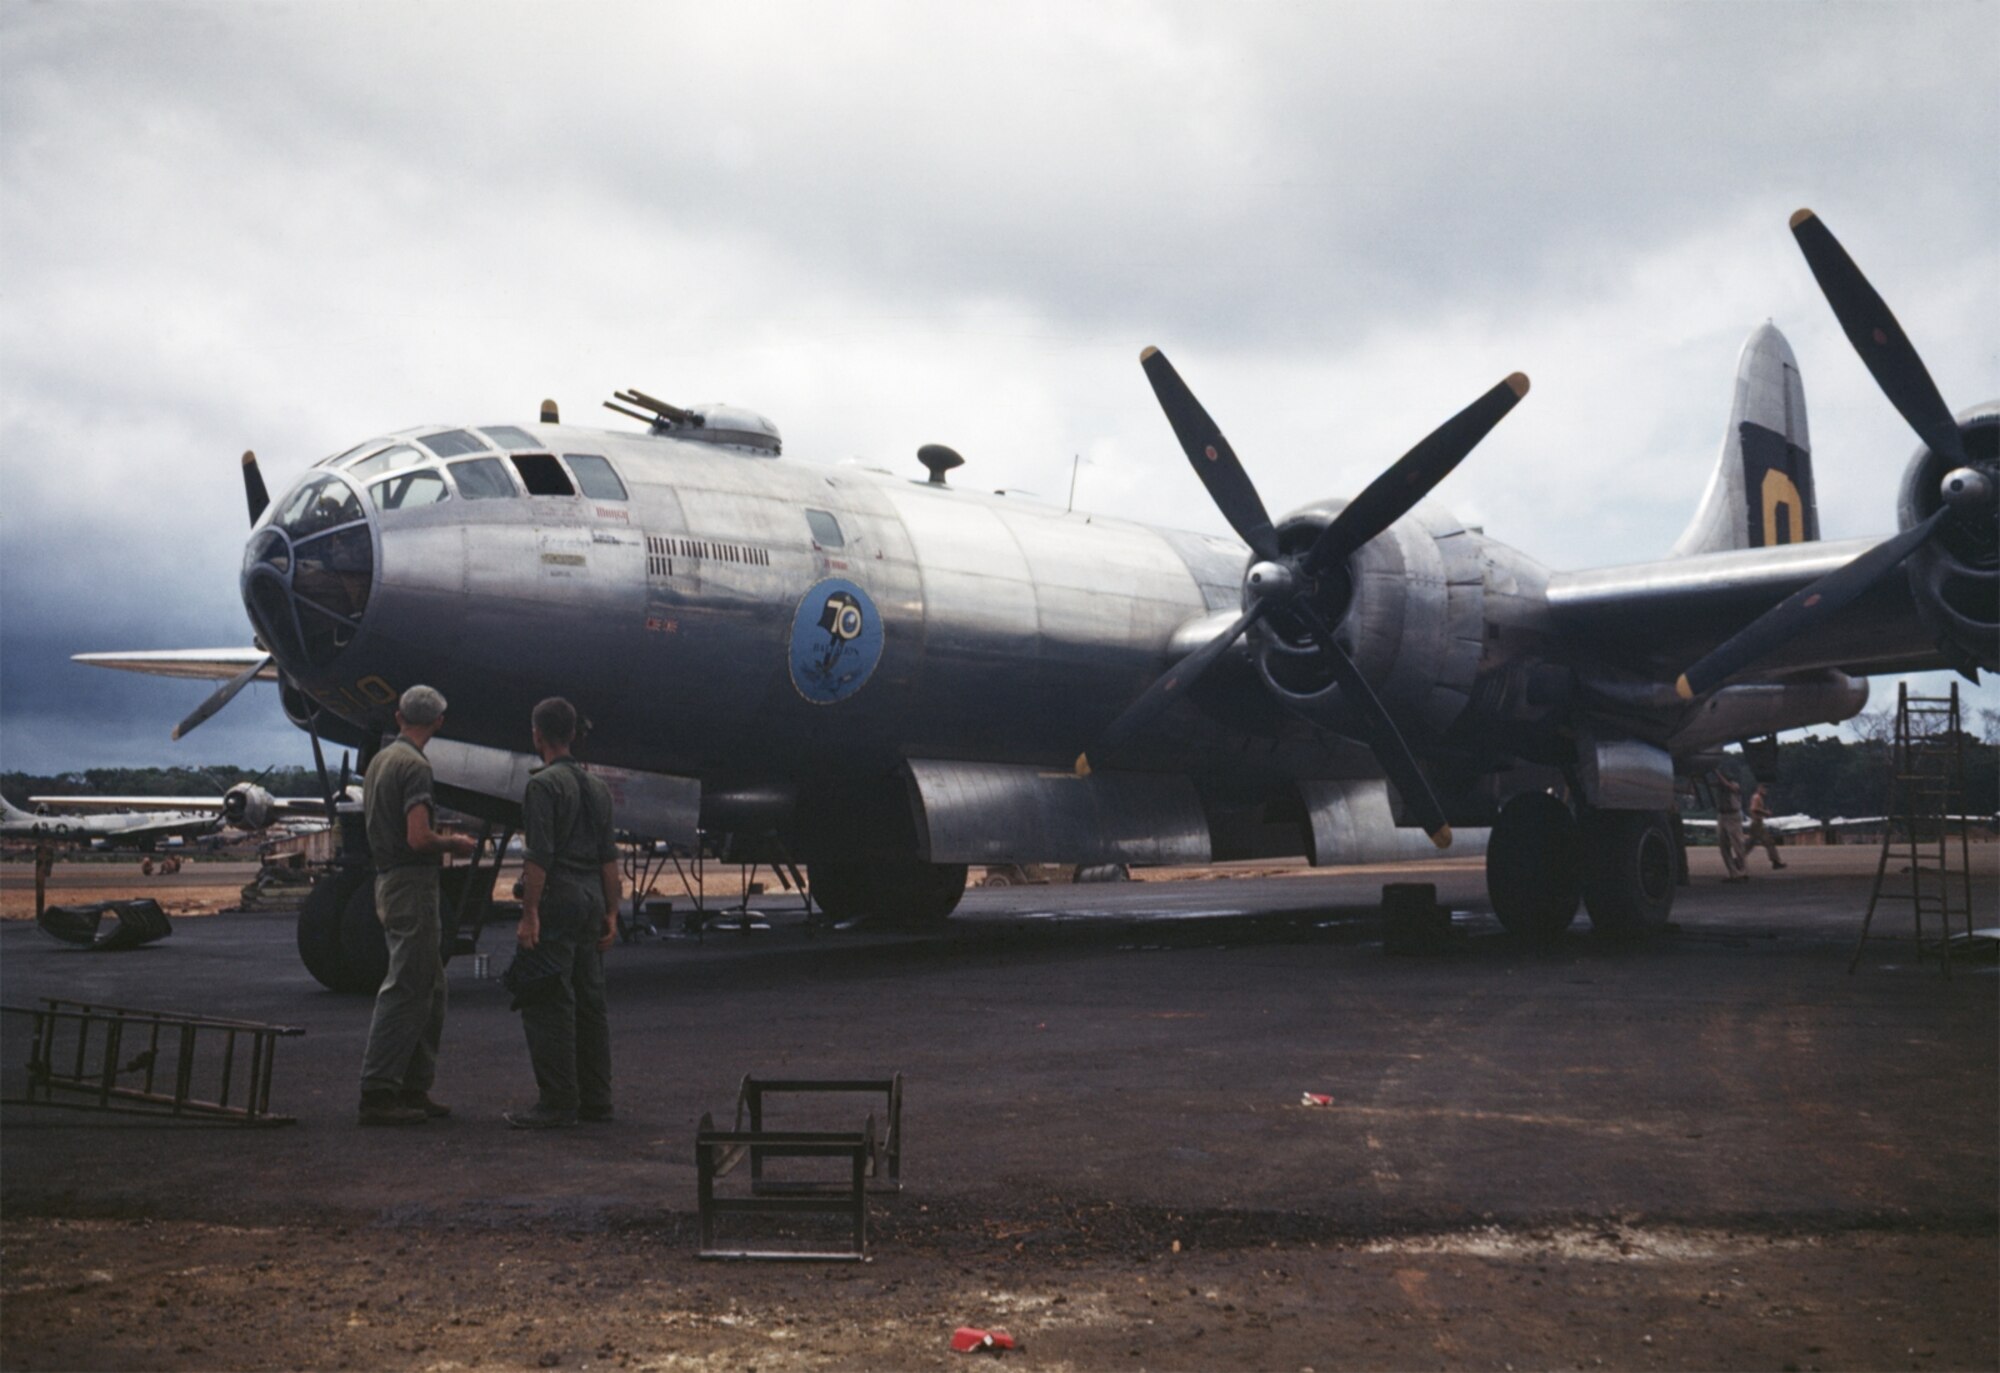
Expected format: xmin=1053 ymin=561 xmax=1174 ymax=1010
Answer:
xmin=1254 ymin=500 xmax=1486 ymax=737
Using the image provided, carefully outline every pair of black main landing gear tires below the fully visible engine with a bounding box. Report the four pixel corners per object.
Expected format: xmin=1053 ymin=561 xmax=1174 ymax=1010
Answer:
xmin=1486 ymin=793 xmax=1674 ymax=945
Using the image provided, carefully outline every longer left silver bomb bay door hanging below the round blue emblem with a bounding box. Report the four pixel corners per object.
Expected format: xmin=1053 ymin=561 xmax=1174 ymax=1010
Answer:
xmin=910 ymin=759 xmax=1210 ymax=863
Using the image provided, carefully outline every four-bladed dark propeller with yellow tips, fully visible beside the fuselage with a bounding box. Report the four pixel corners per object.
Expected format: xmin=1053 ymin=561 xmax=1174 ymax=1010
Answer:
xmin=1076 ymin=348 xmax=1528 ymax=849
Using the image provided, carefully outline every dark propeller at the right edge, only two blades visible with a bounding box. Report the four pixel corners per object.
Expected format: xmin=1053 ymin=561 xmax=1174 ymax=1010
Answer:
xmin=1674 ymin=210 xmax=1994 ymax=701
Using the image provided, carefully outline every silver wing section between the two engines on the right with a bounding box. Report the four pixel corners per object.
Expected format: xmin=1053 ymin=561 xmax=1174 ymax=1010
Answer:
xmin=1548 ymin=538 xmax=1952 ymax=682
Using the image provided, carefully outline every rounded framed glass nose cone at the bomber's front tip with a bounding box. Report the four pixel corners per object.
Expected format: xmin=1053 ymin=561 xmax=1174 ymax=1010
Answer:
xmin=242 ymin=474 xmax=376 ymax=676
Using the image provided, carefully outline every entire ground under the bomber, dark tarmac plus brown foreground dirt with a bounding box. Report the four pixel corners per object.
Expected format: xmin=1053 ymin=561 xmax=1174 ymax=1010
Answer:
xmin=0 ymin=851 xmax=2000 ymax=1373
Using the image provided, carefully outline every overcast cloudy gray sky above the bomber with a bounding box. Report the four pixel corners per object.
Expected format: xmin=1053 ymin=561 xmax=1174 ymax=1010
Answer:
xmin=0 ymin=0 xmax=2000 ymax=771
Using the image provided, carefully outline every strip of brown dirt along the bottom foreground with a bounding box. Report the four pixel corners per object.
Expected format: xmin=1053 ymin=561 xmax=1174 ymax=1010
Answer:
xmin=0 ymin=1217 xmax=2000 ymax=1373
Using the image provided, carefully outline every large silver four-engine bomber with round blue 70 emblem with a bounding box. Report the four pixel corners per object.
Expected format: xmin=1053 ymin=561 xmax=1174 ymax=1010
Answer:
xmin=82 ymin=210 xmax=2000 ymax=985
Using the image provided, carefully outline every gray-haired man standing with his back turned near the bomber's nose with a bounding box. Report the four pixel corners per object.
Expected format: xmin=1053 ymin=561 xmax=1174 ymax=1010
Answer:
xmin=360 ymin=687 xmax=472 ymax=1125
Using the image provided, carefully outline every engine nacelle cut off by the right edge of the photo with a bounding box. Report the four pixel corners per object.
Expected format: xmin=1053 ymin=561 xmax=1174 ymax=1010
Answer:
xmin=1896 ymin=402 xmax=2000 ymax=672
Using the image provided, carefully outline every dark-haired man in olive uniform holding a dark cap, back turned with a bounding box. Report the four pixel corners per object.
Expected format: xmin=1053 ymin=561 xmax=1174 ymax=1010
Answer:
xmin=506 ymin=697 xmax=624 ymax=1129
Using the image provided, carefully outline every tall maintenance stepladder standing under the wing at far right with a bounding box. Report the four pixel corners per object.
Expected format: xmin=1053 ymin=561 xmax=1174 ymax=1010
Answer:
xmin=1848 ymin=682 xmax=1972 ymax=977
